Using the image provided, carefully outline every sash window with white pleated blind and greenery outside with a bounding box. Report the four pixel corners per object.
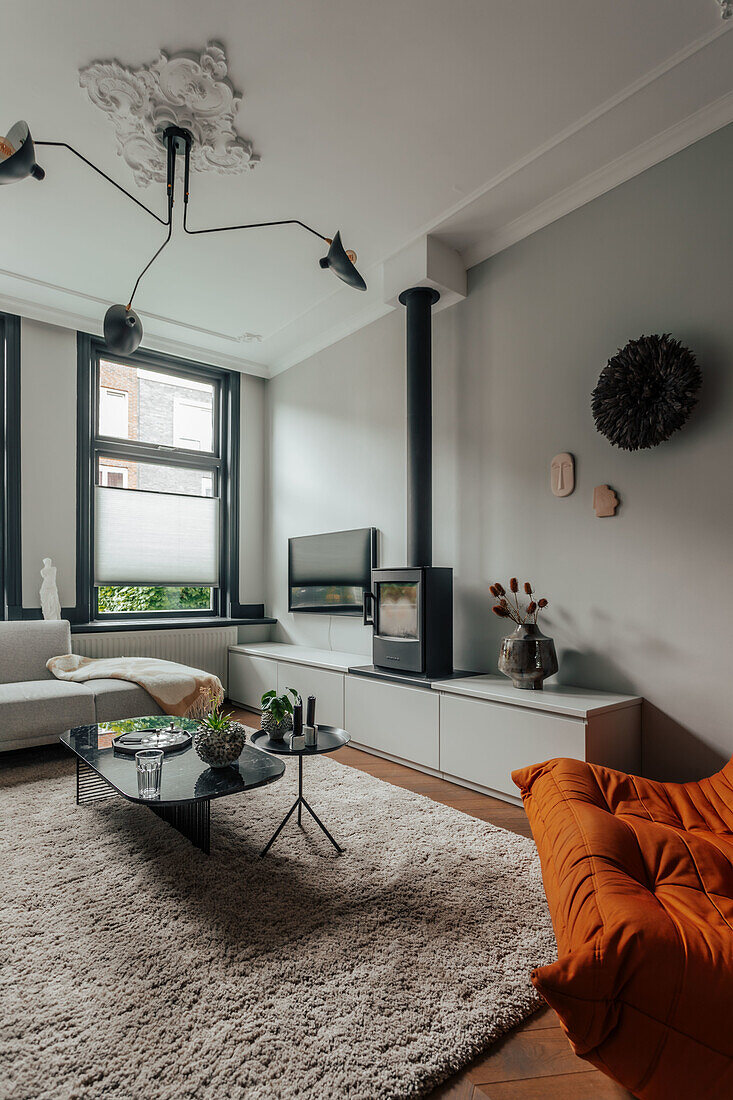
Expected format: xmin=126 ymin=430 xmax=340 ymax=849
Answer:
xmin=88 ymin=348 xmax=230 ymax=618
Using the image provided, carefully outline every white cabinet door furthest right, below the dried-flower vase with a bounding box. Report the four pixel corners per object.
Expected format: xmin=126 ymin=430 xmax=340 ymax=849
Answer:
xmin=440 ymin=694 xmax=586 ymax=799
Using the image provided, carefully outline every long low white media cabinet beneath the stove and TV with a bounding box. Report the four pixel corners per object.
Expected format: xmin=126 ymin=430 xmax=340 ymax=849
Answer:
xmin=228 ymin=642 xmax=642 ymax=805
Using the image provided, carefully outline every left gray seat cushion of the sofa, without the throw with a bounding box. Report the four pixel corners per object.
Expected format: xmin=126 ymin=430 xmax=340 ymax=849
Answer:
xmin=0 ymin=680 xmax=96 ymax=749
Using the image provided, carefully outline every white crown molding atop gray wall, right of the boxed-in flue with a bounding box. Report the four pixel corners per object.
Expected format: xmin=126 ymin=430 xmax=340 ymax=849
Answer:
xmin=461 ymin=85 xmax=733 ymax=267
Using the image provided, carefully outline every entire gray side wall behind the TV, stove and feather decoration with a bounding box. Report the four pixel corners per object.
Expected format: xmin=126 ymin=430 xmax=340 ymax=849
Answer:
xmin=266 ymin=127 xmax=733 ymax=779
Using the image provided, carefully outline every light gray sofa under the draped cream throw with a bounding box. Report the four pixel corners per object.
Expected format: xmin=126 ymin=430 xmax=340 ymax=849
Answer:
xmin=0 ymin=620 xmax=163 ymax=752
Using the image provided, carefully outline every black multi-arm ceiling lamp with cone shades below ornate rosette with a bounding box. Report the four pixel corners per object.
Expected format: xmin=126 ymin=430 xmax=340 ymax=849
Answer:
xmin=0 ymin=122 xmax=367 ymax=355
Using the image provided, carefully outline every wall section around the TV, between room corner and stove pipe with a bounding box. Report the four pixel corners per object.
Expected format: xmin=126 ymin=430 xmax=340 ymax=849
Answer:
xmin=267 ymin=314 xmax=405 ymax=655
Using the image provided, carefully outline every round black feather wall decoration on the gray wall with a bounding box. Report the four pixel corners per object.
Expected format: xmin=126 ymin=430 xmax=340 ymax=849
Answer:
xmin=591 ymin=333 xmax=702 ymax=451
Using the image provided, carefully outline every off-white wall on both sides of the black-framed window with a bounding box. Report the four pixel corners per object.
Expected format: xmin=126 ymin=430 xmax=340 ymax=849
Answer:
xmin=21 ymin=318 xmax=264 ymax=607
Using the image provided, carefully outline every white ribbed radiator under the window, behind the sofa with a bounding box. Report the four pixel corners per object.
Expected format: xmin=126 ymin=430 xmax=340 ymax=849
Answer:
xmin=72 ymin=626 xmax=237 ymax=689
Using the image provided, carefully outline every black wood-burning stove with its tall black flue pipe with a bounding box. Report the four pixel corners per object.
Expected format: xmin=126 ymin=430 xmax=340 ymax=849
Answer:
xmin=364 ymin=286 xmax=453 ymax=680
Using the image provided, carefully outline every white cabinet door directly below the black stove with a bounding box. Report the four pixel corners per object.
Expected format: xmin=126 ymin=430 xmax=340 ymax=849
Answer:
xmin=344 ymin=675 xmax=439 ymax=771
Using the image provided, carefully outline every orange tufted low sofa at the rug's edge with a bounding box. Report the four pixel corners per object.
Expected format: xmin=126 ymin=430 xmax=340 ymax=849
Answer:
xmin=513 ymin=760 xmax=733 ymax=1100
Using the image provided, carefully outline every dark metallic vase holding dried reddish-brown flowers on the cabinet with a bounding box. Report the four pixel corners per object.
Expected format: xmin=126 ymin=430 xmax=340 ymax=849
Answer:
xmin=489 ymin=576 xmax=557 ymax=691
